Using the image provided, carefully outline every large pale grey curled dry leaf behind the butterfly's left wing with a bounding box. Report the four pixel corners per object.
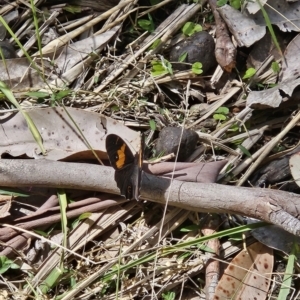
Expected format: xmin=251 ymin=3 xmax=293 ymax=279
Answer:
xmin=0 ymin=107 xmax=140 ymax=160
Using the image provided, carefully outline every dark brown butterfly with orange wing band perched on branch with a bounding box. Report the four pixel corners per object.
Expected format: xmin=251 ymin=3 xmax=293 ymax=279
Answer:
xmin=105 ymin=134 xmax=144 ymax=200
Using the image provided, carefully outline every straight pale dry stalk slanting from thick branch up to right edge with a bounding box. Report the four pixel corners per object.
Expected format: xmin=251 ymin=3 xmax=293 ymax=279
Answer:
xmin=238 ymin=111 xmax=300 ymax=186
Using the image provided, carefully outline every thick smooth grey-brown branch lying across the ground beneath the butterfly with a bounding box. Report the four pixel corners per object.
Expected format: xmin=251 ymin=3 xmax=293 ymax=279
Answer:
xmin=0 ymin=159 xmax=300 ymax=235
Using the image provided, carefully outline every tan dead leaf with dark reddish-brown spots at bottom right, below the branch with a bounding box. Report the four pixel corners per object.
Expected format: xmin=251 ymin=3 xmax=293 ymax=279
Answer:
xmin=213 ymin=243 xmax=273 ymax=300
